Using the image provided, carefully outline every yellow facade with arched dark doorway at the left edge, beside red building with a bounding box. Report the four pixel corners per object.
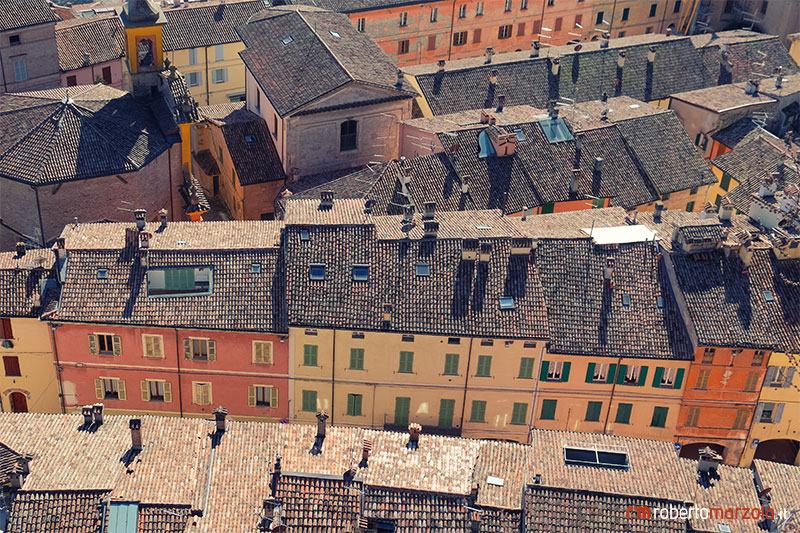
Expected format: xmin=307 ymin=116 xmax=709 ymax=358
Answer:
xmin=0 ymin=317 xmax=62 ymax=413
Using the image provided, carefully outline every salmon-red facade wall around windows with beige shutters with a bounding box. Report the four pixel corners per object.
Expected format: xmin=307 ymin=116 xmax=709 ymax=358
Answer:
xmin=56 ymin=324 xmax=289 ymax=419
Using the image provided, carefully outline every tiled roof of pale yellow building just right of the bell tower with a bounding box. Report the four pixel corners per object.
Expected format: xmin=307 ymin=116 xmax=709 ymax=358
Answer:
xmin=163 ymin=0 xmax=265 ymax=52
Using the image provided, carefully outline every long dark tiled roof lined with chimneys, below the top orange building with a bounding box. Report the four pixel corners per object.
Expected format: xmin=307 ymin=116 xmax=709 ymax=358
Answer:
xmin=406 ymin=34 xmax=712 ymax=115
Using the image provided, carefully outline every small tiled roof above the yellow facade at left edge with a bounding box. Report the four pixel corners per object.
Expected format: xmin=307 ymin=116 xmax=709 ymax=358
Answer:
xmin=0 ymin=250 xmax=55 ymax=317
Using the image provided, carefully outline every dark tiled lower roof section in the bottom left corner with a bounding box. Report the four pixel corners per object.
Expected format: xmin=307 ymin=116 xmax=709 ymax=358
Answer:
xmin=5 ymin=490 xmax=108 ymax=533
